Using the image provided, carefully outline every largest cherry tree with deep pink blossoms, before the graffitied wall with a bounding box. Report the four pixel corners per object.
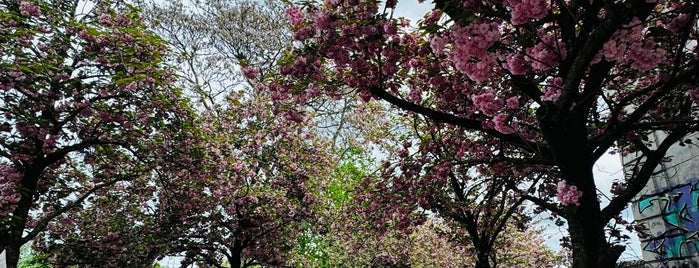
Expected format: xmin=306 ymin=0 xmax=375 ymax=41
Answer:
xmin=268 ymin=0 xmax=699 ymax=267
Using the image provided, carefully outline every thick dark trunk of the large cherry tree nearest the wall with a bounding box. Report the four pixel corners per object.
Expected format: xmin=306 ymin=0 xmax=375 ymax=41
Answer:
xmin=537 ymin=103 xmax=621 ymax=268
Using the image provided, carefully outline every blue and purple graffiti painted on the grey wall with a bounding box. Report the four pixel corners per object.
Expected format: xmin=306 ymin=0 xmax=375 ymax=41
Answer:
xmin=638 ymin=178 xmax=699 ymax=259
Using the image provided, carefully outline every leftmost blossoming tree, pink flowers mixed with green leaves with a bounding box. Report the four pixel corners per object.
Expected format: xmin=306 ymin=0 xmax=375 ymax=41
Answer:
xmin=0 ymin=0 xmax=187 ymax=267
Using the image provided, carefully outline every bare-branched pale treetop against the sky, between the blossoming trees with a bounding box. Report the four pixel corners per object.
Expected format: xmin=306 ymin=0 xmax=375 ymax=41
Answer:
xmin=140 ymin=0 xmax=291 ymax=109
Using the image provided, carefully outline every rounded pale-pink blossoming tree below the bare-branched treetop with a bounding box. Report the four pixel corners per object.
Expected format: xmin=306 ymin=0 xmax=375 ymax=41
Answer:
xmin=164 ymin=90 xmax=333 ymax=267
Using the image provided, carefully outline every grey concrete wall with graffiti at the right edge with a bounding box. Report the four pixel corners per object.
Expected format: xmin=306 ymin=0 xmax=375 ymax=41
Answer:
xmin=622 ymin=133 xmax=699 ymax=268
